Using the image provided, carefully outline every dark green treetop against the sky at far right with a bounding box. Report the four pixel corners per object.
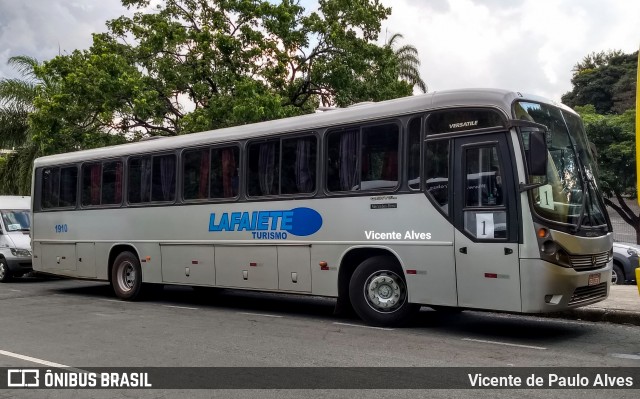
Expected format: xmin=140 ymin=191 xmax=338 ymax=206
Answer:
xmin=562 ymin=51 xmax=638 ymax=114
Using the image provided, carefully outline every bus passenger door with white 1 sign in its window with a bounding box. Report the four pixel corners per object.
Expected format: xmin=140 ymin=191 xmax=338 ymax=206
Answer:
xmin=452 ymin=132 xmax=522 ymax=311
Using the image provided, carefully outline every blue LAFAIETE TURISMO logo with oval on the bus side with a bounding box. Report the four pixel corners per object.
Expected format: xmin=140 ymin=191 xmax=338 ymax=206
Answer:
xmin=209 ymin=208 xmax=322 ymax=240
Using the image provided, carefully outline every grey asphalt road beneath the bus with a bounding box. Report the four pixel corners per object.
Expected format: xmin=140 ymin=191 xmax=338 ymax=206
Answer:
xmin=0 ymin=279 xmax=640 ymax=398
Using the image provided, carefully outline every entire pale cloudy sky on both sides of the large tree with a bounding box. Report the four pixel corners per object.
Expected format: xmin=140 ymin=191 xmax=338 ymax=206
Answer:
xmin=0 ymin=0 xmax=640 ymax=101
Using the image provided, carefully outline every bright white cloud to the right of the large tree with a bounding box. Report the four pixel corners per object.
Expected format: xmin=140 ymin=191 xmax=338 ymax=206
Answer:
xmin=383 ymin=0 xmax=640 ymax=100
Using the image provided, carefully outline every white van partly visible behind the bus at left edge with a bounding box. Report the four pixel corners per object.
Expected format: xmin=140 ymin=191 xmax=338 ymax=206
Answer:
xmin=0 ymin=196 xmax=33 ymax=282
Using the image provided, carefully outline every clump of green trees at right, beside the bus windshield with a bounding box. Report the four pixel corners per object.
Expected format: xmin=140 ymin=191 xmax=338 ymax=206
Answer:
xmin=562 ymin=50 xmax=640 ymax=244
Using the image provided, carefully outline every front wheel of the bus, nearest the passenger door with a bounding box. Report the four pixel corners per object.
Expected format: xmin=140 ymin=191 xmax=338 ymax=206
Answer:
xmin=349 ymin=255 xmax=420 ymax=326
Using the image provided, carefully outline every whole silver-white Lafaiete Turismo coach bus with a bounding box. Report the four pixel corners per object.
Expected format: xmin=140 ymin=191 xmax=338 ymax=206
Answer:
xmin=31 ymin=89 xmax=613 ymax=325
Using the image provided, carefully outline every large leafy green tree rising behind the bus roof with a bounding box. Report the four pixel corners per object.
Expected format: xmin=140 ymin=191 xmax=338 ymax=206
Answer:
xmin=31 ymin=0 xmax=426 ymax=141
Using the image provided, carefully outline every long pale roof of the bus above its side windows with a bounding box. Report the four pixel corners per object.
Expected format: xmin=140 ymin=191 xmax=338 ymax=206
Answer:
xmin=34 ymin=89 xmax=568 ymax=167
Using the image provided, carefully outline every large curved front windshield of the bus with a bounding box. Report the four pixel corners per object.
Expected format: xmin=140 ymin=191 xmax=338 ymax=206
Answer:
xmin=515 ymin=101 xmax=607 ymax=227
